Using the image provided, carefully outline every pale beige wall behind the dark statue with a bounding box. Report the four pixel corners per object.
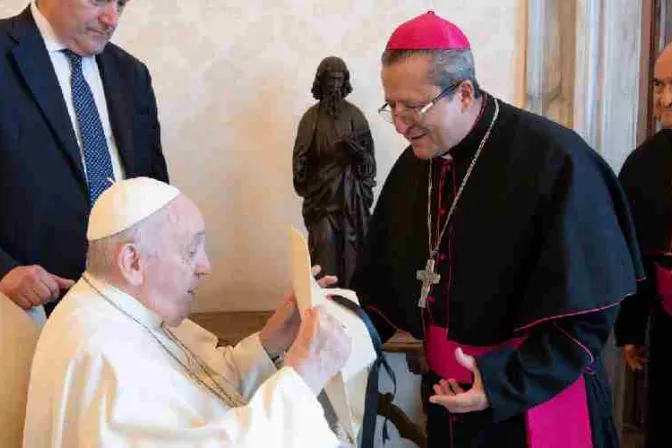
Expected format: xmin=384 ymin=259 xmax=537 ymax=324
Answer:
xmin=0 ymin=0 xmax=524 ymax=311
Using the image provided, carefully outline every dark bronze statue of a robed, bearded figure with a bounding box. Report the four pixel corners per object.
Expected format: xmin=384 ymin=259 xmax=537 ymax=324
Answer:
xmin=293 ymin=56 xmax=376 ymax=287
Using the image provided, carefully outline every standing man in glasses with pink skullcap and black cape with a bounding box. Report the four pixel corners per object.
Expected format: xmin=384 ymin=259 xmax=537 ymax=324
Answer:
xmin=352 ymin=11 xmax=642 ymax=448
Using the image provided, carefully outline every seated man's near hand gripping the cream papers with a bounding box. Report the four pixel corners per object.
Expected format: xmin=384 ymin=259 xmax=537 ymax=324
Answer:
xmin=285 ymin=306 xmax=352 ymax=395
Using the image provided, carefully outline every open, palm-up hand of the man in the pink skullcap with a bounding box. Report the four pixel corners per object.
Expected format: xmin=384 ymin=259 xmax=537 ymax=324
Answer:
xmin=429 ymin=348 xmax=490 ymax=414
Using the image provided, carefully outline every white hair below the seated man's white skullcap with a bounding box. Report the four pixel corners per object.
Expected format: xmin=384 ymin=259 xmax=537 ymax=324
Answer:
xmin=86 ymin=204 xmax=174 ymax=278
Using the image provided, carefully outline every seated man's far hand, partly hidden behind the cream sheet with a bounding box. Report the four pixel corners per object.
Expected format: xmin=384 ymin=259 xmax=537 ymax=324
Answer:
xmin=259 ymin=265 xmax=338 ymax=358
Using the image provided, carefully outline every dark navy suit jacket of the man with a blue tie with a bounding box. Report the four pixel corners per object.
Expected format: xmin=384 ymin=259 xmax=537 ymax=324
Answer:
xmin=0 ymin=8 xmax=168 ymax=300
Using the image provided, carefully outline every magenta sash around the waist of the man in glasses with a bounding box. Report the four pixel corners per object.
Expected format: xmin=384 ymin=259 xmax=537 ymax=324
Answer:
xmin=425 ymin=324 xmax=593 ymax=448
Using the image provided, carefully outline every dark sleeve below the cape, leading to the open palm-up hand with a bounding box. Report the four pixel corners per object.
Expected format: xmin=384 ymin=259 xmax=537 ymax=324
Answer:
xmin=477 ymin=306 xmax=618 ymax=422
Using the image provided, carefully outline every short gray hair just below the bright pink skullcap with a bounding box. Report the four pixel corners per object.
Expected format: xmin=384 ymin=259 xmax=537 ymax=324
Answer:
xmin=381 ymin=49 xmax=481 ymax=98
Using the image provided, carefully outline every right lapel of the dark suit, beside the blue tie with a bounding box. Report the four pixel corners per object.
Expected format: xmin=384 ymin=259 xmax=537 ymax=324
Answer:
xmin=96 ymin=49 xmax=135 ymax=177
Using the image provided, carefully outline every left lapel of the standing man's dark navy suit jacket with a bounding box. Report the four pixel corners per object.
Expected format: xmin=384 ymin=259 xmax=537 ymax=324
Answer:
xmin=11 ymin=8 xmax=87 ymax=191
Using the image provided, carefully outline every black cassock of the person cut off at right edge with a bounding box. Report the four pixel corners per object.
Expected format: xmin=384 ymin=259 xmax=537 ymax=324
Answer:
xmin=615 ymin=129 xmax=672 ymax=447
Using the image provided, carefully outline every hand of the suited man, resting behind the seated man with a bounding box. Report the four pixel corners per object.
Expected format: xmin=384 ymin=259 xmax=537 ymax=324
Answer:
xmin=0 ymin=265 xmax=75 ymax=310
